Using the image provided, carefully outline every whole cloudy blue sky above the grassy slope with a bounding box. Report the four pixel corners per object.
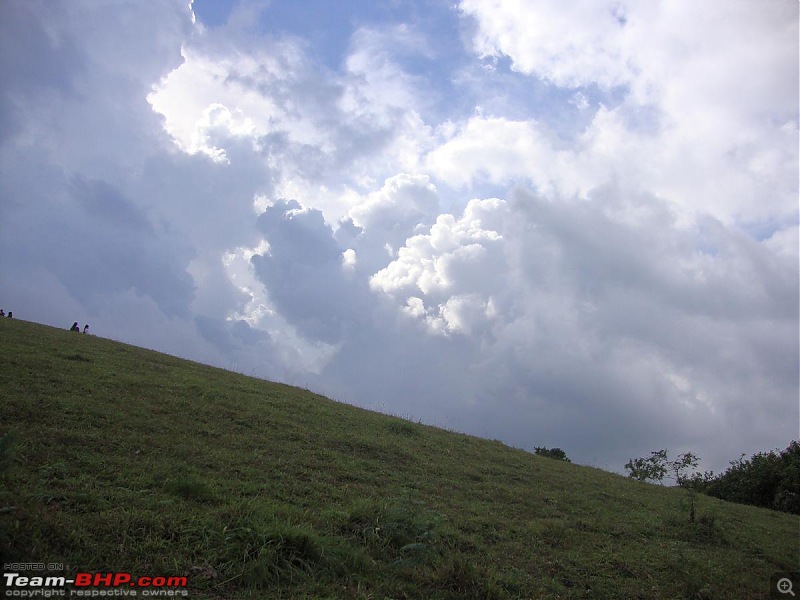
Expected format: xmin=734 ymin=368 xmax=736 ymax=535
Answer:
xmin=0 ymin=0 xmax=800 ymax=472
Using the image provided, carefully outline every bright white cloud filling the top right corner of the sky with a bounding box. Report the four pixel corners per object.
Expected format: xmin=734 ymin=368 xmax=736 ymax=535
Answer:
xmin=460 ymin=0 xmax=798 ymax=227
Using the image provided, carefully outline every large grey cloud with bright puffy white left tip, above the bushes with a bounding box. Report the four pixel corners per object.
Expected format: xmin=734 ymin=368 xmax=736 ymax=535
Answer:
xmin=358 ymin=187 xmax=797 ymax=468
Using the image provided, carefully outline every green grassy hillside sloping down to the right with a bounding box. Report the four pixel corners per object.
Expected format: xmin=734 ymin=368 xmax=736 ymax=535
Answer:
xmin=0 ymin=319 xmax=800 ymax=599
